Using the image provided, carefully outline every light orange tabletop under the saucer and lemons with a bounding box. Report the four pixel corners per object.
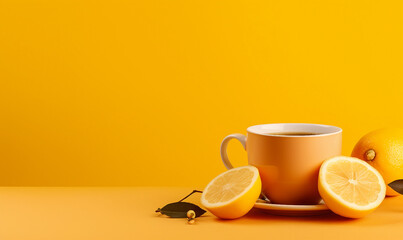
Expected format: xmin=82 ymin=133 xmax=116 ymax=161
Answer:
xmin=0 ymin=187 xmax=403 ymax=240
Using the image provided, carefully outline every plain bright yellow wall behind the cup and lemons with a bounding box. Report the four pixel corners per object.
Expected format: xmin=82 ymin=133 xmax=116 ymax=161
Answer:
xmin=0 ymin=0 xmax=403 ymax=188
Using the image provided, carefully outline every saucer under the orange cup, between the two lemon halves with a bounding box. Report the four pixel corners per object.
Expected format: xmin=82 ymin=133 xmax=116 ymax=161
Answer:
xmin=254 ymin=199 xmax=330 ymax=217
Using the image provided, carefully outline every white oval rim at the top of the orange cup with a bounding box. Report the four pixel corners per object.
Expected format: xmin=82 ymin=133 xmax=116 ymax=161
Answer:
xmin=246 ymin=123 xmax=343 ymax=138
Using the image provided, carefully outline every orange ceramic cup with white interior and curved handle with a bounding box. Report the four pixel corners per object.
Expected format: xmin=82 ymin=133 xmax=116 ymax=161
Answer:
xmin=221 ymin=123 xmax=342 ymax=204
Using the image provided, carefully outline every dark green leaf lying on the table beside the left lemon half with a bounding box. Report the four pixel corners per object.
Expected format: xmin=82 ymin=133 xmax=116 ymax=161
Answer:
xmin=156 ymin=202 xmax=206 ymax=218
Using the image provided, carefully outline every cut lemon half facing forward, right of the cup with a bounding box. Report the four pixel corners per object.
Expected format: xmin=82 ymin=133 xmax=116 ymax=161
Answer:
xmin=318 ymin=156 xmax=386 ymax=218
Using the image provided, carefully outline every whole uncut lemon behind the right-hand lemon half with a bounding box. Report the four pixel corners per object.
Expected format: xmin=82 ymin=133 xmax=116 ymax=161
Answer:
xmin=351 ymin=128 xmax=403 ymax=196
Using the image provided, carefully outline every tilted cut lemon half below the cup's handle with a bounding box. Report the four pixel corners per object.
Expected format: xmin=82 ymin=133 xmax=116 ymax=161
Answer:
xmin=201 ymin=166 xmax=262 ymax=219
